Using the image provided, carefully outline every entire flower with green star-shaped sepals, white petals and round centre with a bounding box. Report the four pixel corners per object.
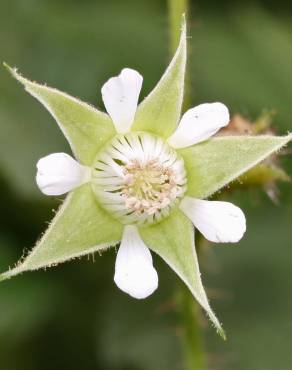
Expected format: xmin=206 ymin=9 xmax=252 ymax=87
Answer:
xmin=0 ymin=20 xmax=291 ymax=335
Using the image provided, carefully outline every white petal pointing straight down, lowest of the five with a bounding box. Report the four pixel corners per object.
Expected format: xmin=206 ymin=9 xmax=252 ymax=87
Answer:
xmin=114 ymin=225 xmax=158 ymax=299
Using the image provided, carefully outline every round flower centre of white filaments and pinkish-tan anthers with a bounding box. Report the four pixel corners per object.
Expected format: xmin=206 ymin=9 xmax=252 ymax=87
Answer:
xmin=92 ymin=133 xmax=186 ymax=224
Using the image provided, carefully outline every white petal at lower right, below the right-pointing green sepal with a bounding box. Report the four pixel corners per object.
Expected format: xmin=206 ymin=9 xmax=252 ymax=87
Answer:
xmin=180 ymin=197 xmax=246 ymax=243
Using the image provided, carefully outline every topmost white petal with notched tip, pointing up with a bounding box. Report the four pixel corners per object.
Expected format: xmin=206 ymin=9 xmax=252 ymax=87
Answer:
xmin=101 ymin=68 xmax=143 ymax=134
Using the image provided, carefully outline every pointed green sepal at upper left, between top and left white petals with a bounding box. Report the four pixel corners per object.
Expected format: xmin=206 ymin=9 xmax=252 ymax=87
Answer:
xmin=4 ymin=64 xmax=116 ymax=165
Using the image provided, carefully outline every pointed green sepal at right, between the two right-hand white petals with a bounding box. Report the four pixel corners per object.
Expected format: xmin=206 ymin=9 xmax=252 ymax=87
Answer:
xmin=179 ymin=135 xmax=292 ymax=199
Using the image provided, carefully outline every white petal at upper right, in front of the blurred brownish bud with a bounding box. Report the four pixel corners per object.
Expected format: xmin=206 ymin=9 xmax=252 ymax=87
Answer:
xmin=168 ymin=103 xmax=230 ymax=148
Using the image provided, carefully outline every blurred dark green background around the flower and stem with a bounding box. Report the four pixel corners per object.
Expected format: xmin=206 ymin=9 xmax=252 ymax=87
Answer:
xmin=0 ymin=0 xmax=292 ymax=370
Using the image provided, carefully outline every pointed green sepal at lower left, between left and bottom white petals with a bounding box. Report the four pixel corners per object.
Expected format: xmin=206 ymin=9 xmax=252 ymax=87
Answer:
xmin=0 ymin=184 xmax=123 ymax=280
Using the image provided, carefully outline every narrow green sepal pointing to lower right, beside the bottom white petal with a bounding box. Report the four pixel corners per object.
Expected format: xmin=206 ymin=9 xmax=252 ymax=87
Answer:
xmin=139 ymin=210 xmax=225 ymax=338
